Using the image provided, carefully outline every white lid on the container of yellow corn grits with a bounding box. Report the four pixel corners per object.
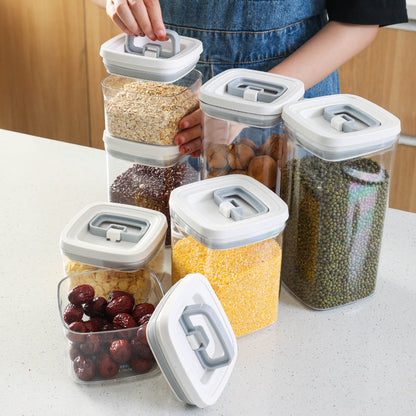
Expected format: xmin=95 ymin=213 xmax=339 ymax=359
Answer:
xmin=169 ymin=175 xmax=289 ymax=250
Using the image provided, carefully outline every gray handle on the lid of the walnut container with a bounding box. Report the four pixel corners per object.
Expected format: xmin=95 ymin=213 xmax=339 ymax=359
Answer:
xmin=227 ymin=78 xmax=287 ymax=103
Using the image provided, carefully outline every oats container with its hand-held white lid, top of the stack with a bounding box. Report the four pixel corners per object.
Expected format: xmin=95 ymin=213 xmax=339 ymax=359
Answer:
xmin=100 ymin=31 xmax=202 ymax=146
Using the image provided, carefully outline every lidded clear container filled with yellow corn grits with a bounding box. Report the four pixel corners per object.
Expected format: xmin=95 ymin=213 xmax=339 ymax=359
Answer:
xmin=170 ymin=175 xmax=288 ymax=337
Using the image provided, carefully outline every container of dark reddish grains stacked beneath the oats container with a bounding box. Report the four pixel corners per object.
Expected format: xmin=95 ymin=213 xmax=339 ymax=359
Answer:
xmin=103 ymin=132 xmax=200 ymax=246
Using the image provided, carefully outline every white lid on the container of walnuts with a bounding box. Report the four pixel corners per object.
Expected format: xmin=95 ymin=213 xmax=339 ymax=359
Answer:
xmin=199 ymin=68 xmax=305 ymax=127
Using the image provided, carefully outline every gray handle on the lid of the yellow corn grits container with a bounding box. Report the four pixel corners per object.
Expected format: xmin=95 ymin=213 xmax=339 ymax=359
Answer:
xmin=214 ymin=186 xmax=269 ymax=221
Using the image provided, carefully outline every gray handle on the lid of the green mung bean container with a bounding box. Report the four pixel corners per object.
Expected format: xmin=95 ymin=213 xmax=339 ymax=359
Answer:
xmin=324 ymin=104 xmax=381 ymax=133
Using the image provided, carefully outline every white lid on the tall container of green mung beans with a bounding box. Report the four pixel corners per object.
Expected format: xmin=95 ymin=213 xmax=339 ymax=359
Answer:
xmin=282 ymin=94 xmax=400 ymax=161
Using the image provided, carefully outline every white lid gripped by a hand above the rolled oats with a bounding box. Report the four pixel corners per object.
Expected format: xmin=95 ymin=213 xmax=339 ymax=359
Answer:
xmin=100 ymin=30 xmax=202 ymax=82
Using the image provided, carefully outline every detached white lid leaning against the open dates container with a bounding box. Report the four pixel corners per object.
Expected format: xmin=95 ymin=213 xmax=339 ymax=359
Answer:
xmin=146 ymin=274 xmax=237 ymax=408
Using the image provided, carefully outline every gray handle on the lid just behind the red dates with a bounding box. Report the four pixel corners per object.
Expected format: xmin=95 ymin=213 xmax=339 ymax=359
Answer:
xmin=88 ymin=214 xmax=149 ymax=243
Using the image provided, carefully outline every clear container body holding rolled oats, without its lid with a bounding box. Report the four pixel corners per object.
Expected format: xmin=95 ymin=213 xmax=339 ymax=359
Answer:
xmin=101 ymin=69 xmax=201 ymax=145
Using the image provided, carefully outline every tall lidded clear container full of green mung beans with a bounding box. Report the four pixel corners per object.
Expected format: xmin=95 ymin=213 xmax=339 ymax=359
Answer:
xmin=280 ymin=95 xmax=400 ymax=309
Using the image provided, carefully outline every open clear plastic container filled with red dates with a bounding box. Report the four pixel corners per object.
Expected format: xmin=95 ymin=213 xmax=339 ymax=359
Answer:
xmin=58 ymin=269 xmax=163 ymax=384
